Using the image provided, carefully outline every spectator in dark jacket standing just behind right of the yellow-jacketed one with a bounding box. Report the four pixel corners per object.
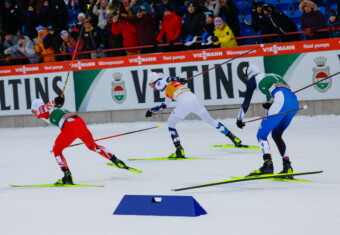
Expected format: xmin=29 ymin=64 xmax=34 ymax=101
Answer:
xmin=218 ymin=0 xmax=241 ymax=40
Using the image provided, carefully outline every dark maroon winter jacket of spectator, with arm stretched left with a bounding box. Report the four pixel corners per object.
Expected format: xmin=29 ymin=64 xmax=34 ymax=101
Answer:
xmin=120 ymin=13 xmax=155 ymax=46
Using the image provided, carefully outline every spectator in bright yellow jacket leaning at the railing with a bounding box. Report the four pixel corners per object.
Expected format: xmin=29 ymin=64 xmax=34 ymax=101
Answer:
xmin=212 ymin=17 xmax=237 ymax=48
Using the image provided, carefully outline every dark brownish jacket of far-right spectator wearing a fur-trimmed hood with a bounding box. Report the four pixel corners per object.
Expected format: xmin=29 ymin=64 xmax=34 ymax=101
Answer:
xmin=301 ymin=10 xmax=328 ymax=40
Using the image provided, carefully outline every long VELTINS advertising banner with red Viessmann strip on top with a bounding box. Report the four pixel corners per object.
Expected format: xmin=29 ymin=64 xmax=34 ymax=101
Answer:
xmin=0 ymin=39 xmax=340 ymax=115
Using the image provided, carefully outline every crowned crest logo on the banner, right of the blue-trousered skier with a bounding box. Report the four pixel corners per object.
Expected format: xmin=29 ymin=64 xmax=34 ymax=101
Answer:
xmin=313 ymin=56 xmax=332 ymax=93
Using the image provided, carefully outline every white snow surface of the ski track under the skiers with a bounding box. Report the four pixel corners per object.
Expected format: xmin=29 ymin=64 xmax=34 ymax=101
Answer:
xmin=0 ymin=116 xmax=340 ymax=235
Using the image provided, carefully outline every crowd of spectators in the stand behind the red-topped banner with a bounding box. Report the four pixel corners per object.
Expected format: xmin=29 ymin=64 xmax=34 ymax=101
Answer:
xmin=0 ymin=0 xmax=340 ymax=65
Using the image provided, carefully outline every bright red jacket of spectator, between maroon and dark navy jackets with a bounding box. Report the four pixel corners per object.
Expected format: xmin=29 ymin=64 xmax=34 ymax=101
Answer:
xmin=156 ymin=11 xmax=182 ymax=43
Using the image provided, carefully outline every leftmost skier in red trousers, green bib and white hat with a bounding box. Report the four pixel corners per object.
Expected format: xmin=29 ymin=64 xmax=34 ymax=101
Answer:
xmin=31 ymin=96 xmax=127 ymax=184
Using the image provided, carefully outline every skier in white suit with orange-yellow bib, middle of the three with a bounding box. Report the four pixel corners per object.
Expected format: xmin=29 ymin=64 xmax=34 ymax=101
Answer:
xmin=145 ymin=72 xmax=242 ymax=158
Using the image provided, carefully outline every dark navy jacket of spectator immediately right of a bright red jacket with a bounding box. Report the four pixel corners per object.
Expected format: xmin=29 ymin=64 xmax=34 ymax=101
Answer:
xmin=178 ymin=11 xmax=205 ymax=40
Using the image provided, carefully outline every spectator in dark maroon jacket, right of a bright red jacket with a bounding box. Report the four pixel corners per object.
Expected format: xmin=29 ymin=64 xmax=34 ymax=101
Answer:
xmin=120 ymin=6 xmax=156 ymax=54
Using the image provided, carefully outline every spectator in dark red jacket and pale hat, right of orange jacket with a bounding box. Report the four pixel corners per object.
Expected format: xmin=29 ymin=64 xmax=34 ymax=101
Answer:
xmin=60 ymin=30 xmax=88 ymax=60
